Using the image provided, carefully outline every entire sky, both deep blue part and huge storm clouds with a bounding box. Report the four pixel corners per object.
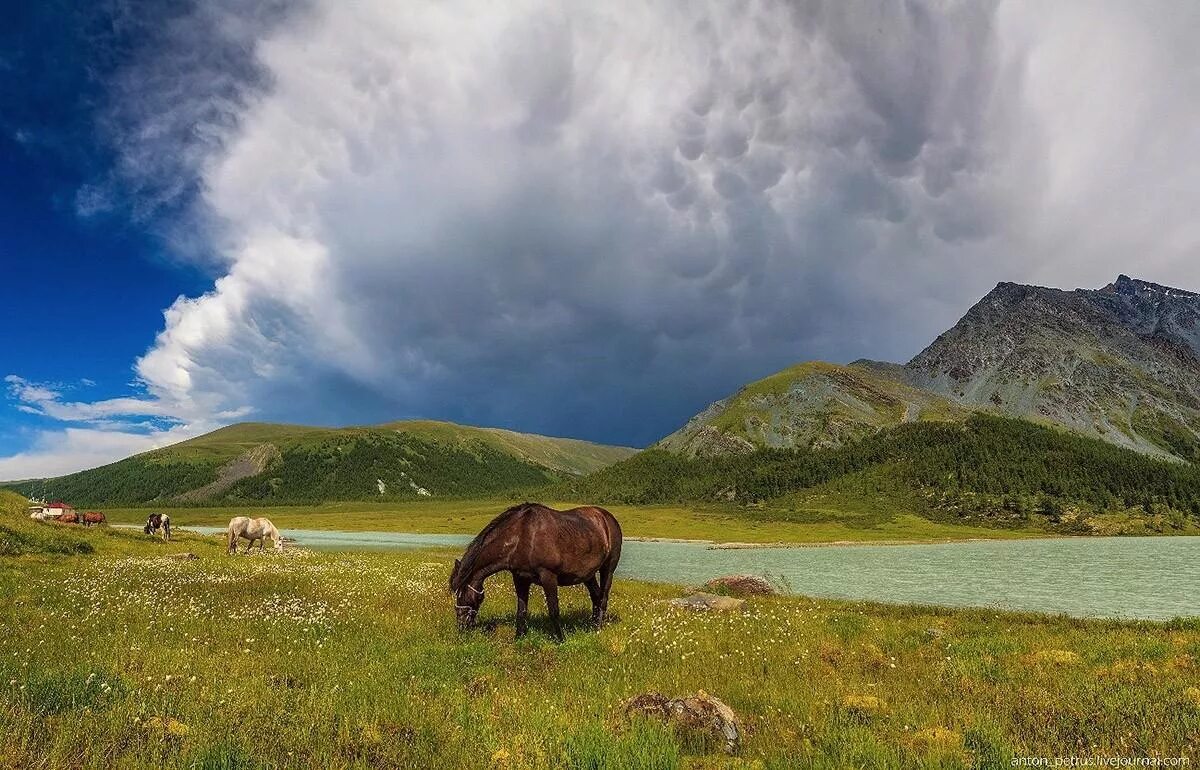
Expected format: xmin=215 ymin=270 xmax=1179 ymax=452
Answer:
xmin=0 ymin=0 xmax=1200 ymax=479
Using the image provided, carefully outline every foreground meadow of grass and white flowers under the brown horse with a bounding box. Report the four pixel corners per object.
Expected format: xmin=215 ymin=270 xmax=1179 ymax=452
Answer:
xmin=0 ymin=541 xmax=1200 ymax=769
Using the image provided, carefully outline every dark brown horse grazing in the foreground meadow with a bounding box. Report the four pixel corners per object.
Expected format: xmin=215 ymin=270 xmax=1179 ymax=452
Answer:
xmin=450 ymin=503 xmax=622 ymax=642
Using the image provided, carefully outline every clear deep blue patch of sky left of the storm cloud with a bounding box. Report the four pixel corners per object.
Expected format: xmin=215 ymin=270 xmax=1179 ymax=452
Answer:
xmin=0 ymin=2 xmax=211 ymax=470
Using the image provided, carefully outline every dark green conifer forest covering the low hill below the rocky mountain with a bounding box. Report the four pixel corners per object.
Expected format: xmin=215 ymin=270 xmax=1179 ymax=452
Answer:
xmin=559 ymin=415 xmax=1200 ymax=516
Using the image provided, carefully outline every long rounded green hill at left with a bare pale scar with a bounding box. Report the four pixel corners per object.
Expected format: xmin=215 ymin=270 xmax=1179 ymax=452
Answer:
xmin=10 ymin=421 xmax=635 ymax=506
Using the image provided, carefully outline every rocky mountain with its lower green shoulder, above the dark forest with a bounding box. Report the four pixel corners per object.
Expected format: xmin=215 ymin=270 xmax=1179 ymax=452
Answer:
xmin=656 ymin=276 xmax=1200 ymax=461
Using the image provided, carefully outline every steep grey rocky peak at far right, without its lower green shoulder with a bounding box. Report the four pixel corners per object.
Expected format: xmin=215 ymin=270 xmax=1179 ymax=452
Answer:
xmin=905 ymin=275 xmax=1200 ymax=458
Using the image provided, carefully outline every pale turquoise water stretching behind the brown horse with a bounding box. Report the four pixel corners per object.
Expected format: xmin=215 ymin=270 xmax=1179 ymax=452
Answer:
xmin=145 ymin=527 xmax=1200 ymax=620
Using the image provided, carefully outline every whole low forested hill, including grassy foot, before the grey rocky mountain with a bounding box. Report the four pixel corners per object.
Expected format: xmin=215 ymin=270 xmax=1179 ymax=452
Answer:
xmin=557 ymin=414 xmax=1200 ymax=533
